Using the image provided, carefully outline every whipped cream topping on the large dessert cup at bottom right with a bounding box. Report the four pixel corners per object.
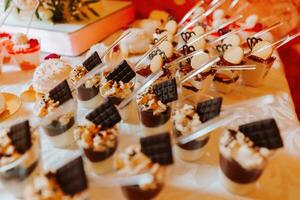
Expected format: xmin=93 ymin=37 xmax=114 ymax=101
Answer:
xmin=220 ymin=130 xmax=271 ymax=170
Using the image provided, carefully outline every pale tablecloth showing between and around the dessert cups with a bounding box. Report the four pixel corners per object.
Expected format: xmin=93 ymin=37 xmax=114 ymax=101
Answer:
xmin=0 ymin=30 xmax=300 ymax=200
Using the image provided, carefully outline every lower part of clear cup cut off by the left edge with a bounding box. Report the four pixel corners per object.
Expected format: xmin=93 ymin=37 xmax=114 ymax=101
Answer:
xmin=0 ymin=135 xmax=41 ymax=198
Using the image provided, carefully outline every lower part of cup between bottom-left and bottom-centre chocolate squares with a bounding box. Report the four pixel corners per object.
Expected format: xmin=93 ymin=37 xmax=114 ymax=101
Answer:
xmin=81 ymin=140 xmax=118 ymax=175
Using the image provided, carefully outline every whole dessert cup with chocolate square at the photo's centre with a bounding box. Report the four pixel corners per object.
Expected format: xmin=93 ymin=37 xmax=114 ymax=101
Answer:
xmin=137 ymin=79 xmax=178 ymax=136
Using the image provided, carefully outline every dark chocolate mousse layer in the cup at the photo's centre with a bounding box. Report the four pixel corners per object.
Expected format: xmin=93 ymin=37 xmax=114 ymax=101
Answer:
xmin=140 ymin=106 xmax=172 ymax=128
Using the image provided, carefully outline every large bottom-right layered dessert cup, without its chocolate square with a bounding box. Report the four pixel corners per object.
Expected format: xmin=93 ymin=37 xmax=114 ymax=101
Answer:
xmin=220 ymin=129 xmax=271 ymax=194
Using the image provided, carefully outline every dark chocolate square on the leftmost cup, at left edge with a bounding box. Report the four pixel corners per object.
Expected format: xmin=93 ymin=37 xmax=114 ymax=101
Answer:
xmin=8 ymin=120 xmax=32 ymax=154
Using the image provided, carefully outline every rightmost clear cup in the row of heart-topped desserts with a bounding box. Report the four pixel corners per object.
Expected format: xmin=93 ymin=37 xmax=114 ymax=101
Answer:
xmin=242 ymin=55 xmax=276 ymax=87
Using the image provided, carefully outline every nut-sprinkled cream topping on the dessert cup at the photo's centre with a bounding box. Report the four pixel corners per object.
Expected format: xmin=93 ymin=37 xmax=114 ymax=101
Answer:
xmin=137 ymin=87 xmax=167 ymax=115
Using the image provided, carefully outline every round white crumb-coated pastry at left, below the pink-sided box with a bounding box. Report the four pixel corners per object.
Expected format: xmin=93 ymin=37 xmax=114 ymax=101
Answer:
xmin=32 ymin=58 xmax=72 ymax=96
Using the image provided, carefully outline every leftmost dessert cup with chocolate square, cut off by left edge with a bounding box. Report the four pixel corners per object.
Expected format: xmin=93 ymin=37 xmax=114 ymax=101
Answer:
xmin=0 ymin=121 xmax=40 ymax=198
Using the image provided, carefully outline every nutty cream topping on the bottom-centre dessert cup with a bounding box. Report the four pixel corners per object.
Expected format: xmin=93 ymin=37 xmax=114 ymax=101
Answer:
xmin=114 ymin=146 xmax=164 ymax=190
